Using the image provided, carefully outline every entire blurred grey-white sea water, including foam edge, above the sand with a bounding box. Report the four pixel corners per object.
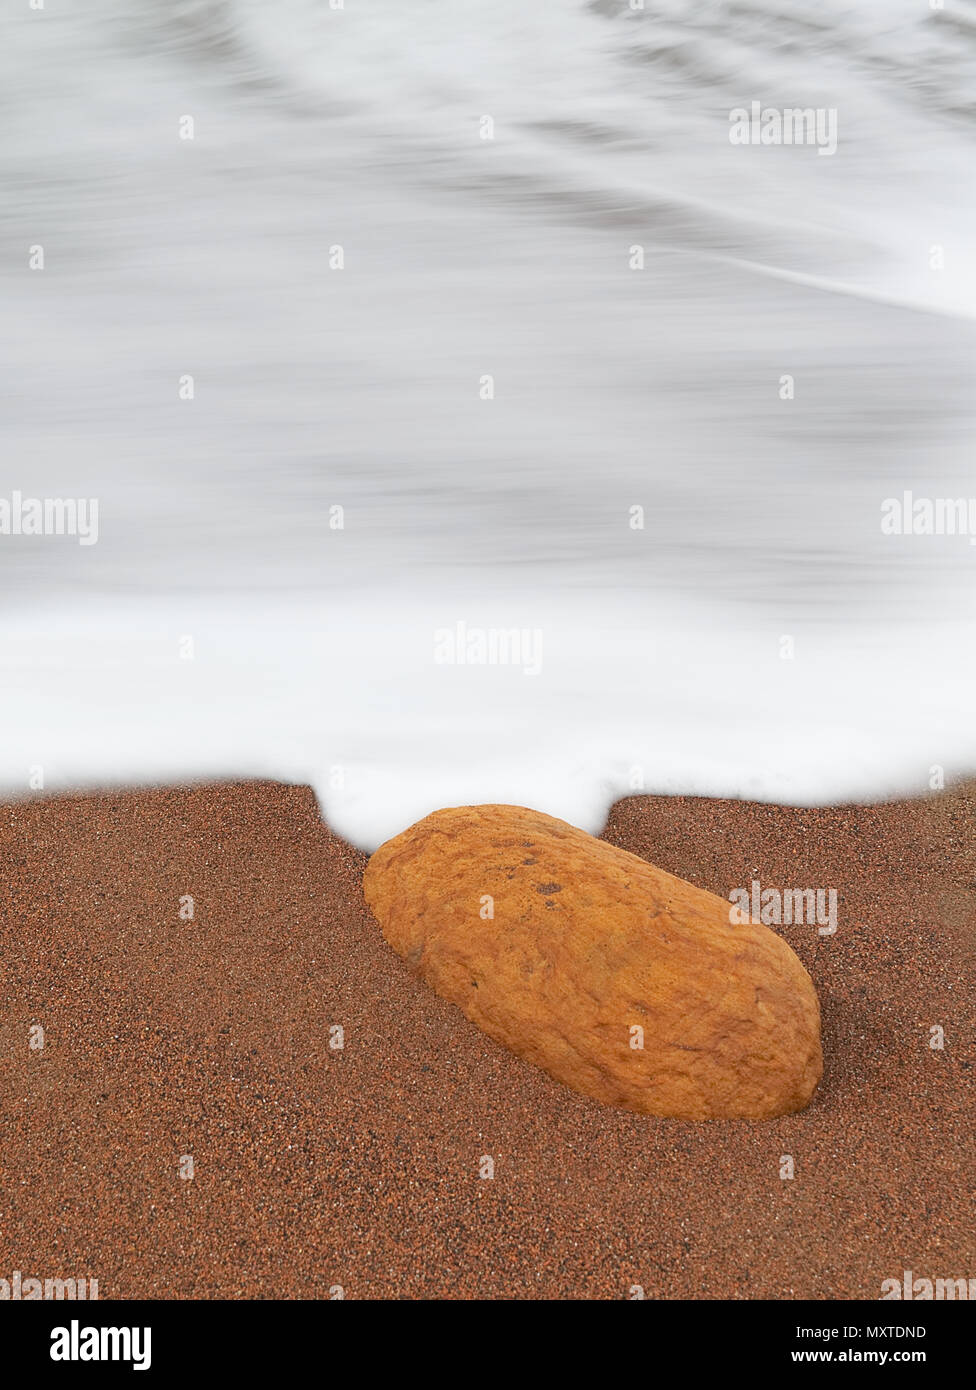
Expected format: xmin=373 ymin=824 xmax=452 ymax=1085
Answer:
xmin=0 ymin=0 xmax=976 ymax=848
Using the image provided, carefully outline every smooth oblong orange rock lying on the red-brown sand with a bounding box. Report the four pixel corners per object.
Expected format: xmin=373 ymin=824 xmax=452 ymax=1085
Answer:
xmin=364 ymin=806 xmax=822 ymax=1120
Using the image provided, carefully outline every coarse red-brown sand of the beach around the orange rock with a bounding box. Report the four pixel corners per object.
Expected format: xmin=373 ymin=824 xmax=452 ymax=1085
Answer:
xmin=0 ymin=784 xmax=976 ymax=1298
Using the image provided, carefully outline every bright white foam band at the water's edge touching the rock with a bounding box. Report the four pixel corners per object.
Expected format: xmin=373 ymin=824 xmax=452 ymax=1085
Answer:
xmin=0 ymin=592 xmax=976 ymax=848
